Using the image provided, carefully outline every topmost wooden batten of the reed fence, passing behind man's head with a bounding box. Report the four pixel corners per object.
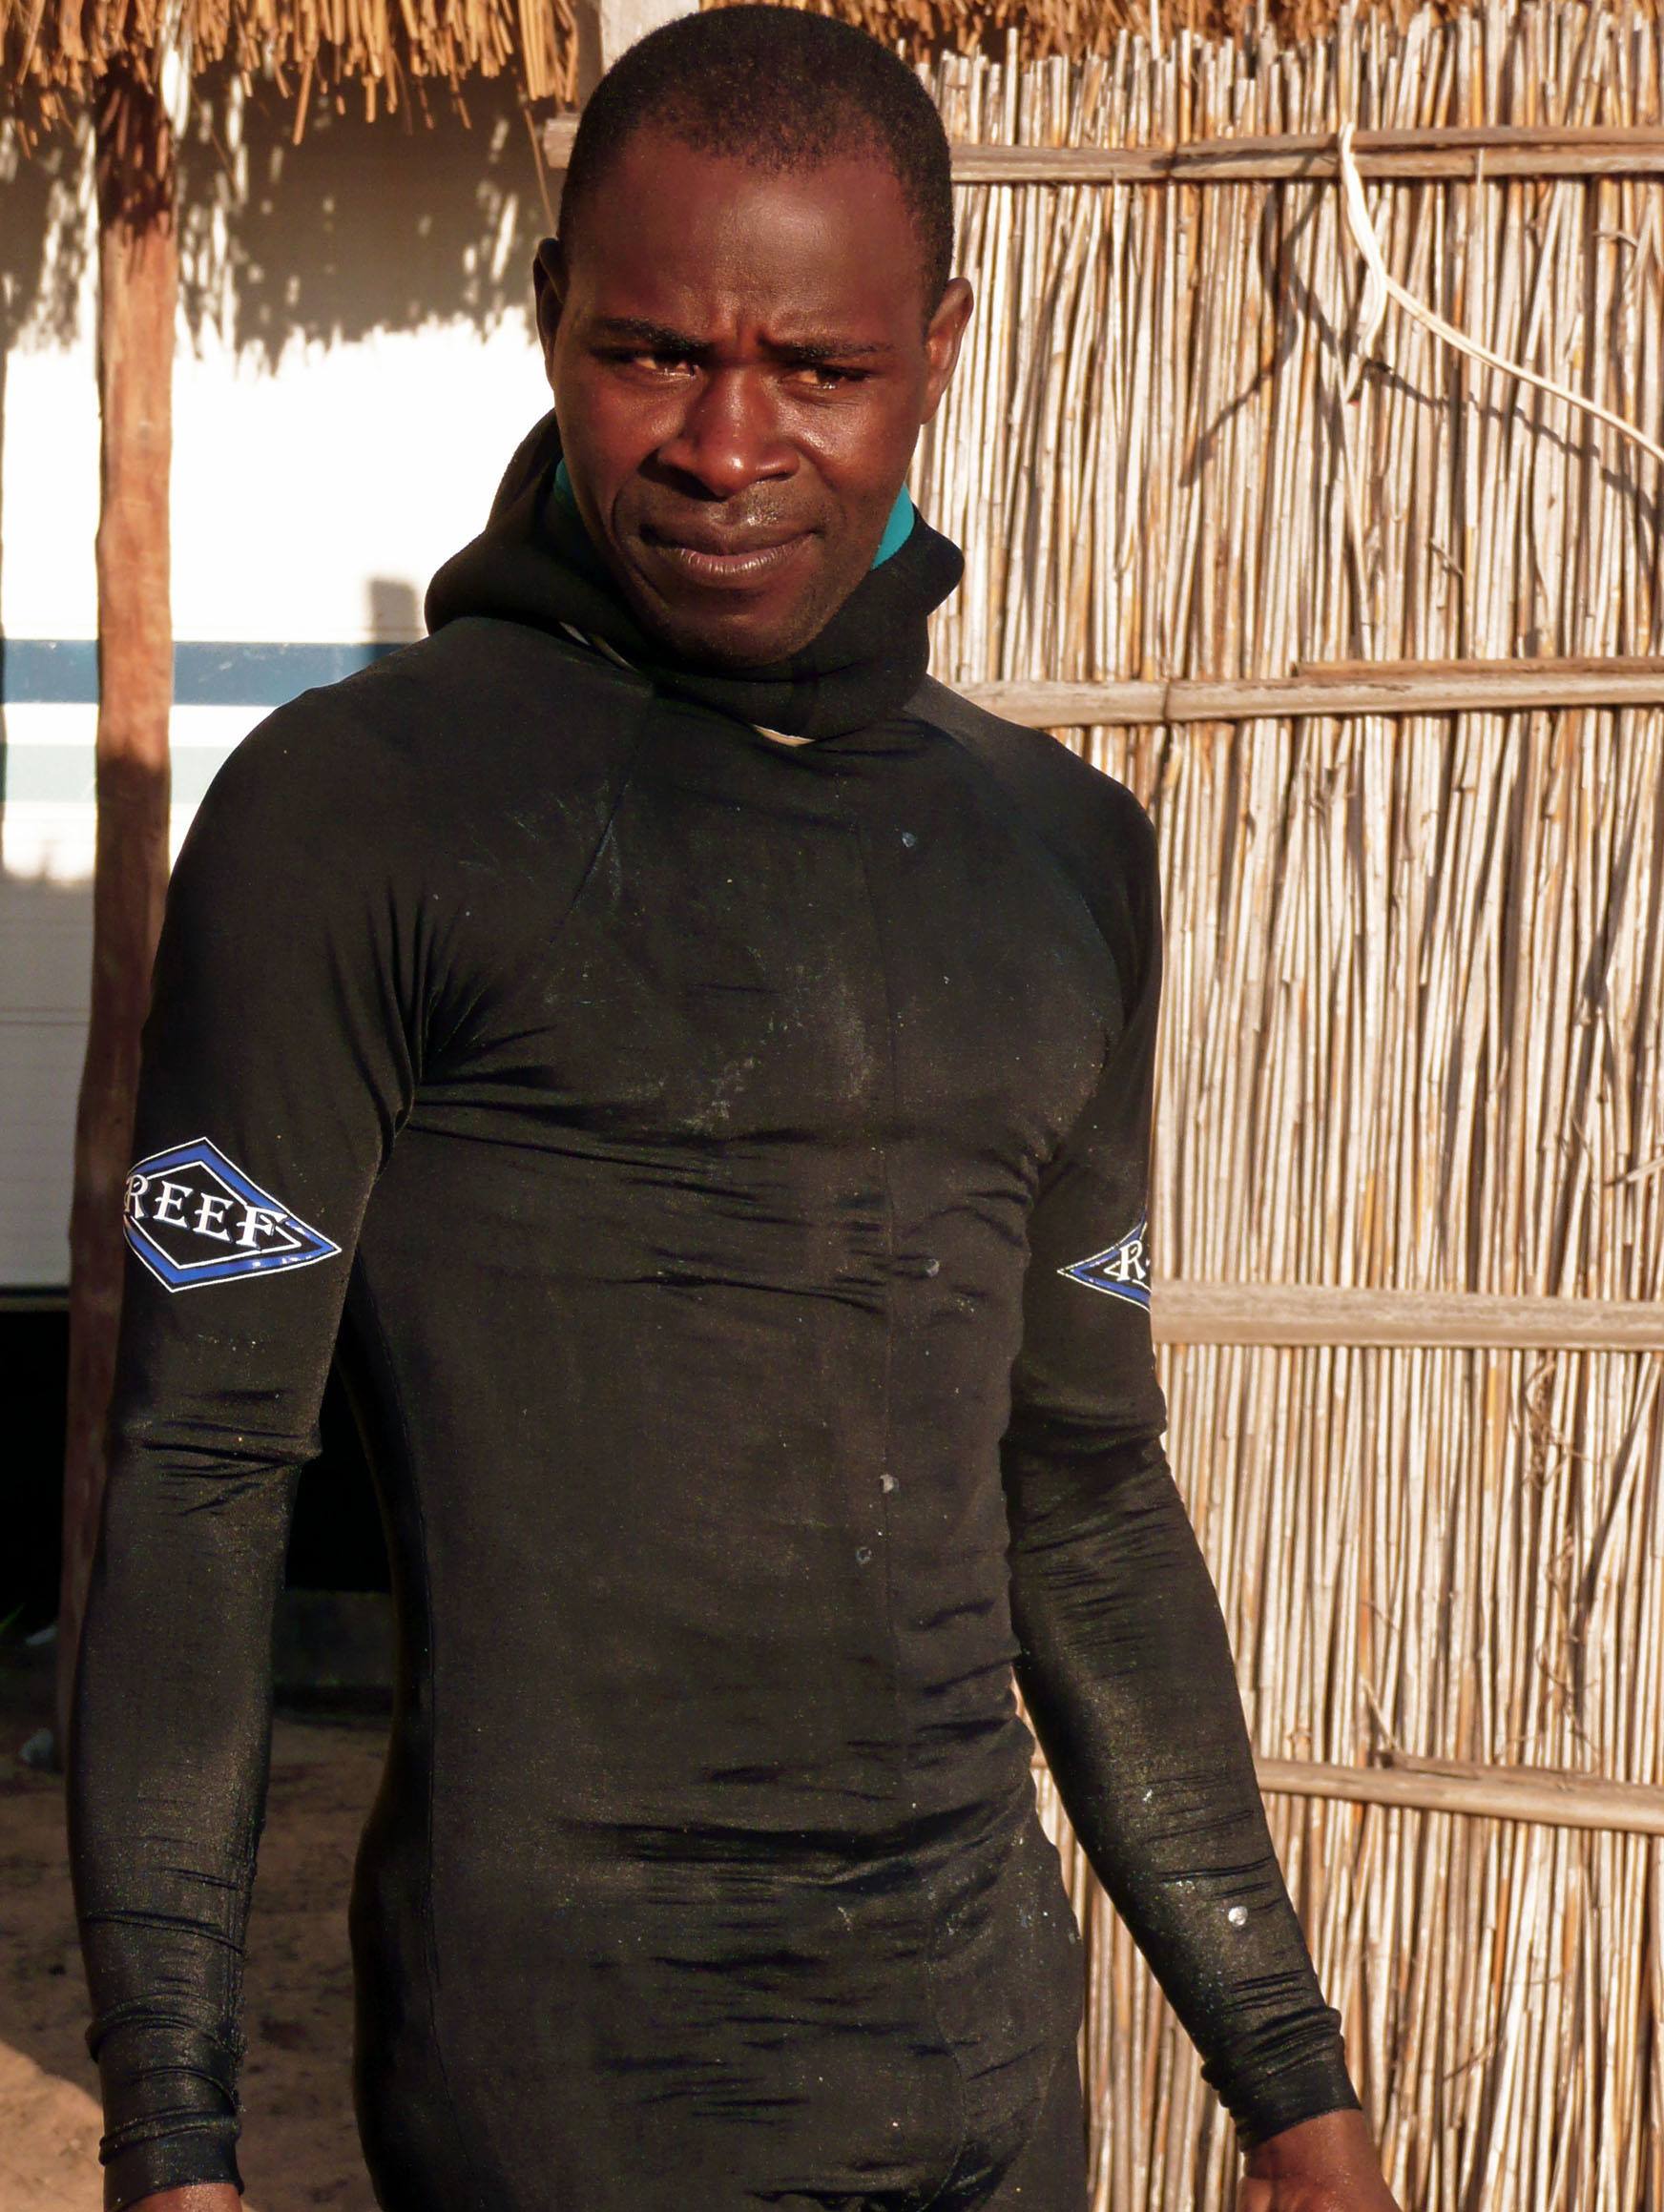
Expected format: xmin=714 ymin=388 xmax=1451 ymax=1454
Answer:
xmin=542 ymin=115 xmax=1664 ymax=183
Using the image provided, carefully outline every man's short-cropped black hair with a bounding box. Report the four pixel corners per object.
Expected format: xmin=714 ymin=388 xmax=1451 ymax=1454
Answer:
xmin=560 ymin=7 xmax=954 ymax=314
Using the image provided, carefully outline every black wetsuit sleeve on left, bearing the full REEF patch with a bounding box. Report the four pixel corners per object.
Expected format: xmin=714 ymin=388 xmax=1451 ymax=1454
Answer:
xmin=69 ymin=701 xmax=425 ymax=2212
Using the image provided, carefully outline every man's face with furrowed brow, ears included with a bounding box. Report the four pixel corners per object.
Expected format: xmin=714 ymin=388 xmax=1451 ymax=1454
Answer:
xmin=538 ymin=129 xmax=971 ymax=668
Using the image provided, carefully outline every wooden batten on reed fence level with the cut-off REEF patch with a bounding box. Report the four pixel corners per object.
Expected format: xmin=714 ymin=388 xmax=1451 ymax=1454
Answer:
xmin=1151 ymin=1281 xmax=1664 ymax=1352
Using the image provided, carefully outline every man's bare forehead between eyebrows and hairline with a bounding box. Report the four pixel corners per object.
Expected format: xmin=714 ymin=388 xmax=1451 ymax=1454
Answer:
xmin=571 ymin=129 xmax=925 ymax=334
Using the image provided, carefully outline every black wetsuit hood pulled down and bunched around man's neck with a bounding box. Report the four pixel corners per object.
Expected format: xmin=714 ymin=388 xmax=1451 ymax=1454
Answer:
xmin=425 ymin=414 xmax=965 ymax=736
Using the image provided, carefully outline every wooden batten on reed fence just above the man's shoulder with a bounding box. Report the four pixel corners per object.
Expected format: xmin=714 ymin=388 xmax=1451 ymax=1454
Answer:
xmin=956 ymin=654 xmax=1664 ymax=730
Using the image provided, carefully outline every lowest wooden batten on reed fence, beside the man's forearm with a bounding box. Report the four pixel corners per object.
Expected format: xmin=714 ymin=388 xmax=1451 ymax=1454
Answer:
xmin=1255 ymin=1756 xmax=1664 ymax=1836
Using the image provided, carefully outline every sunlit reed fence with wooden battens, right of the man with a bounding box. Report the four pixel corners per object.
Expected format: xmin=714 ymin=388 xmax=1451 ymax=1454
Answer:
xmin=898 ymin=0 xmax=1664 ymax=2212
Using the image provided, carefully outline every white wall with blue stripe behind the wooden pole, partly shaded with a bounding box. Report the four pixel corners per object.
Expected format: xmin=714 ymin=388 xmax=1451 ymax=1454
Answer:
xmin=0 ymin=77 xmax=559 ymax=1288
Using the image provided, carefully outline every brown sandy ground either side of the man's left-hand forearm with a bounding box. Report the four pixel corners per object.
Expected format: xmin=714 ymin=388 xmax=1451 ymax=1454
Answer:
xmin=0 ymin=1681 xmax=383 ymax=2212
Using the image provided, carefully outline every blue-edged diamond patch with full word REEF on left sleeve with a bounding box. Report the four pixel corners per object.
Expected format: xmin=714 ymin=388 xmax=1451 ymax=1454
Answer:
xmin=122 ymin=1137 xmax=341 ymax=1290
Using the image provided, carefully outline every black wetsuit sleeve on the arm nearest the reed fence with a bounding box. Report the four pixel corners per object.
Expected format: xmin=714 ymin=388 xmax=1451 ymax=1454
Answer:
xmin=1005 ymin=795 xmax=1359 ymax=2143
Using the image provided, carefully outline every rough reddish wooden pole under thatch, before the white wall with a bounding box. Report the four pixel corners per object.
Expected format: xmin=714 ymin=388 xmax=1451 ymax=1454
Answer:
xmin=57 ymin=67 xmax=179 ymax=1743
